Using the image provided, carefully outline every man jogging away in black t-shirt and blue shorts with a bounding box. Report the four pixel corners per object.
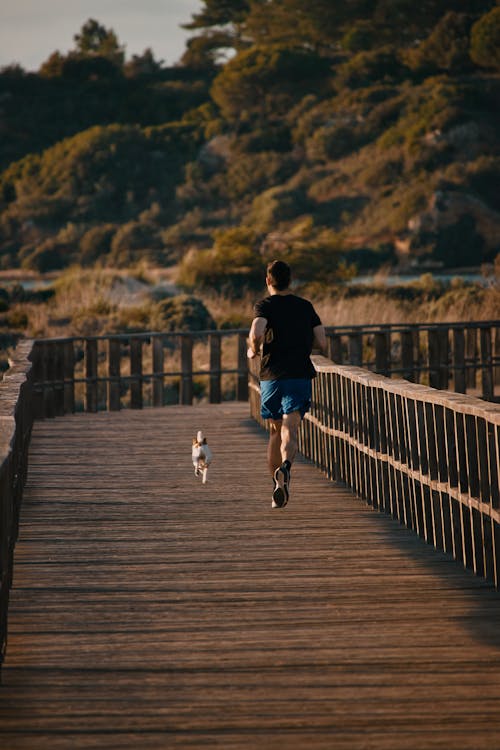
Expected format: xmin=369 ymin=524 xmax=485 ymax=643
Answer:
xmin=248 ymin=260 xmax=326 ymax=508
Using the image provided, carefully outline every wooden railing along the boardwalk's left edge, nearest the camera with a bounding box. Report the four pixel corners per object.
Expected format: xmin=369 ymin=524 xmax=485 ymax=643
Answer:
xmin=0 ymin=341 xmax=33 ymax=666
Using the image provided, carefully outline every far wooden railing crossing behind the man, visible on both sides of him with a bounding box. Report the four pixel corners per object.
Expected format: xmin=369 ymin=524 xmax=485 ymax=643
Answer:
xmin=29 ymin=321 xmax=500 ymax=417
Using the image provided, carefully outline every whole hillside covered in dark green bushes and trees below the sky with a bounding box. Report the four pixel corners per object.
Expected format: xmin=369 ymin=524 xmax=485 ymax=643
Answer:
xmin=0 ymin=0 xmax=500 ymax=295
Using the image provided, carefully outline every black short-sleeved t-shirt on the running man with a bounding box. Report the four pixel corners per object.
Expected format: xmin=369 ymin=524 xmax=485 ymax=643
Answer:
xmin=254 ymin=294 xmax=321 ymax=380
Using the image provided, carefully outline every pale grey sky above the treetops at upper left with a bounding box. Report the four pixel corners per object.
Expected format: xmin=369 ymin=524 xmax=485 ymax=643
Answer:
xmin=0 ymin=0 xmax=202 ymax=70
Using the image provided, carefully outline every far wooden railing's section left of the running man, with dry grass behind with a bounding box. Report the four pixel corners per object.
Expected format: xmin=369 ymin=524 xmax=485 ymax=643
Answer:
xmin=33 ymin=330 xmax=248 ymax=417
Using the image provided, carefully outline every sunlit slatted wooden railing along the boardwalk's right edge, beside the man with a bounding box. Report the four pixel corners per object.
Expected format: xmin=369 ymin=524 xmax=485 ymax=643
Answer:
xmin=250 ymin=357 xmax=500 ymax=587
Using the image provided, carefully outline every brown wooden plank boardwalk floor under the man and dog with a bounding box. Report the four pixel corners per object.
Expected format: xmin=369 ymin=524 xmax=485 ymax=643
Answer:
xmin=0 ymin=404 xmax=500 ymax=750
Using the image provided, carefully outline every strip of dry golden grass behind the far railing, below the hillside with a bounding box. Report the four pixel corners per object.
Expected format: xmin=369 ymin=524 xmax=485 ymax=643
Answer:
xmin=9 ymin=269 xmax=500 ymax=338
